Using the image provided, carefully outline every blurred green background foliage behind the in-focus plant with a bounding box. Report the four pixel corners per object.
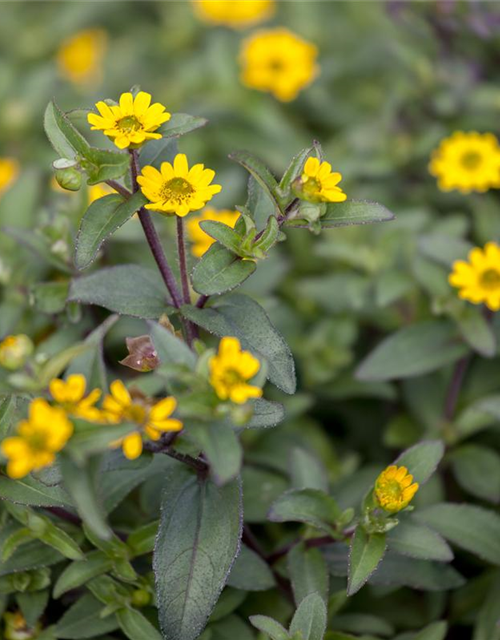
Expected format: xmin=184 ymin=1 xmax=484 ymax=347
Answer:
xmin=0 ymin=0 xmax=500 ymax=640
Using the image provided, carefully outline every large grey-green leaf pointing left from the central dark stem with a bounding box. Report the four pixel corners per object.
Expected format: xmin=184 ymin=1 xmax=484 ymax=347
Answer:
xmin=68 ymin=265 xmax=169 ymax=320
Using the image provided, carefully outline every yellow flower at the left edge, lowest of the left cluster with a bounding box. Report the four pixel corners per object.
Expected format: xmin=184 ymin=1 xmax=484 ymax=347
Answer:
xmin=1 ymin=398 xmax=73 ymax=478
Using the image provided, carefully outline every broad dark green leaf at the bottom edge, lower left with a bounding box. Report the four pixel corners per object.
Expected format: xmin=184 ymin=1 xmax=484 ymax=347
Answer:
xmin=56 ymin=593 xmax=118 ymax=640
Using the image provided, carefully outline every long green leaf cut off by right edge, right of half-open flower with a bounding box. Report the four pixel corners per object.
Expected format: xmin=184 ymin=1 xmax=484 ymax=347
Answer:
xmin=416 ymin=502 xmax=500 ymax=566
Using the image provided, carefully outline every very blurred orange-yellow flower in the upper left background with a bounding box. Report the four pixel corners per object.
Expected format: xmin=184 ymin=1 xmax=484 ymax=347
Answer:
xmin=57 ymin=29 xmax=107 ymax=84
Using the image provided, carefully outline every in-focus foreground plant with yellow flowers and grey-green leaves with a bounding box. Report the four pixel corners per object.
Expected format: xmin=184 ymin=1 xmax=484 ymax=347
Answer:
xmin=0 ymin=86 xmax=466 ymax=640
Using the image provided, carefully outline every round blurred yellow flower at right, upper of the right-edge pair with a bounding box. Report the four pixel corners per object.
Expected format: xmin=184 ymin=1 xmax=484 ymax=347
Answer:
xmin=429 ymin=131 xmax=500 ymax=193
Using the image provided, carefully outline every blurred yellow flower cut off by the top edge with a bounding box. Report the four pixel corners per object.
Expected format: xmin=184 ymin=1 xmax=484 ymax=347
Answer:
xmin=191 ymin=0 xmax=275 ymax=29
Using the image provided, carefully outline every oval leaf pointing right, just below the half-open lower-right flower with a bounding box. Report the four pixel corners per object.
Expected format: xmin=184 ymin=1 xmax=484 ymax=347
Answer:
xmin=387 ymin=521 xmax=453 ymax=562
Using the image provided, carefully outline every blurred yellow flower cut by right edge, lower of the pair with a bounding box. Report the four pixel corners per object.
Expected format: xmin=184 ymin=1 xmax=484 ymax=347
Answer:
xmin=448 ymin=242 xmax=500 ymax=311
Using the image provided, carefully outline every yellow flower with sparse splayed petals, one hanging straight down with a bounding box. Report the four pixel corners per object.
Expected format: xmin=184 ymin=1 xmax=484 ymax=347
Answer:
xmin=102 ymin=380 xmax=182 ymax=460
